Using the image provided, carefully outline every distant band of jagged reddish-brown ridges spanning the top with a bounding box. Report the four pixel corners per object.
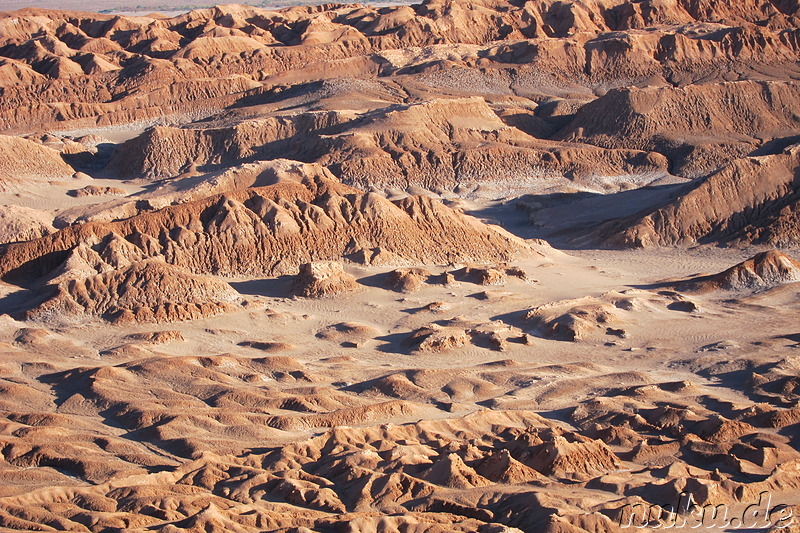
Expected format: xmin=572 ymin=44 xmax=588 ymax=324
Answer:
xmin=0 ymin=0 xmax=797 ymax=129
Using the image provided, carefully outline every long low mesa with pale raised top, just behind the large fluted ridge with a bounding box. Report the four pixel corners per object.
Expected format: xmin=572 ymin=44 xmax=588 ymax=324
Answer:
xmin=110 ymin=97 xmax=667 ymax=188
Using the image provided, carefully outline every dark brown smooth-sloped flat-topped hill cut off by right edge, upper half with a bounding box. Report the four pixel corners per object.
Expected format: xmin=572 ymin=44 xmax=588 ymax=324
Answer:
xmin=559 ymin=80 xmax=800 ymax=178
